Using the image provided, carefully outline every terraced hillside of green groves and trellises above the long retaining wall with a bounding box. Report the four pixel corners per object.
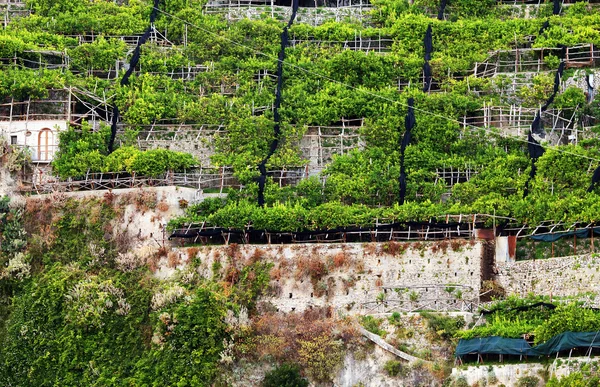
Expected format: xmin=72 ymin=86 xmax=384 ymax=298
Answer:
xmin=0 ymin=1 xmax=600 ymax=231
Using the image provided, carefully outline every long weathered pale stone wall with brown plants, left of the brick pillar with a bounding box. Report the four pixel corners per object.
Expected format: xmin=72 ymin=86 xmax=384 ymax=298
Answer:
xmin=162 ymin=240 xmax=481 ymax=314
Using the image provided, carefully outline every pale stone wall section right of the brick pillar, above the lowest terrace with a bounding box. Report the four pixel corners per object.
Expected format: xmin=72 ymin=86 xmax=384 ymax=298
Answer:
xmin=496 ymin=255 xmax=600 ymax=296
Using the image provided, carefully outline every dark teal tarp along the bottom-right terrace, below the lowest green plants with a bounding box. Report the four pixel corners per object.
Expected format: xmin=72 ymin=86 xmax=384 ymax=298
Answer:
xmin=456 ymin=331 xmax=600 ymax=357
